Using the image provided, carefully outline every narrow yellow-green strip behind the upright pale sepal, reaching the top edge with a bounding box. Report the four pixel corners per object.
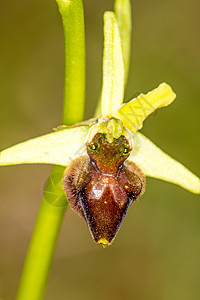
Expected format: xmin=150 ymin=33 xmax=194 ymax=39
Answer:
xmin=115 ymin=0 xmax=132 ymax=83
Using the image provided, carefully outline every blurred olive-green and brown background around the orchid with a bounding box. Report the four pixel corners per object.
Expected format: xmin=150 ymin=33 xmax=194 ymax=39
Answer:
xmin=0 ymin=0 xmax=200 ymax=300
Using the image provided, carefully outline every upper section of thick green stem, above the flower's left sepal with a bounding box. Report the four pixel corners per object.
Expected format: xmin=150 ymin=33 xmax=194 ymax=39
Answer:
xmin=56 ymin=0 xmax=85 ymax=125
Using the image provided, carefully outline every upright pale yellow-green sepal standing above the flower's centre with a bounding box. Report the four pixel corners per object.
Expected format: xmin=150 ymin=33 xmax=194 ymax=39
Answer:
xmin=101 ymin=12 xmax=124 ymax=119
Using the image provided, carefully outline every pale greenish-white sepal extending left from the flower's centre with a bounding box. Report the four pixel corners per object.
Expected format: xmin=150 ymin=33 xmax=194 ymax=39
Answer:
xmin=0 ymin=126 xmax=89 ymax=166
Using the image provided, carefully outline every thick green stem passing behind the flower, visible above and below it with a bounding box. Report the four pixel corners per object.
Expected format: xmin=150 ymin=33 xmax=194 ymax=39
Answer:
xmin=17 ymin=0 xmax=85 ymax=300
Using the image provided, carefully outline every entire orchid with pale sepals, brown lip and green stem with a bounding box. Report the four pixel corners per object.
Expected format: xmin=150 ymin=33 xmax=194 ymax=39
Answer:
xmin=0 ymin=0 xmax=200 ymax=300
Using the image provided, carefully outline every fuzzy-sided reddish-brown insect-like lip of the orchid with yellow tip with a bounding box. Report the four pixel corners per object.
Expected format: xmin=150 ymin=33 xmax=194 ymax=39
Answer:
xmin=63 ymin=133 xmax=145 ymax=246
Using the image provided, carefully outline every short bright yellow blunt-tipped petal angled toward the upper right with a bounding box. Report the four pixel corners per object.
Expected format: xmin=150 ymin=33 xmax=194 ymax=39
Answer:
xmin=118 ymin=83 xmax=176 ymax=133
